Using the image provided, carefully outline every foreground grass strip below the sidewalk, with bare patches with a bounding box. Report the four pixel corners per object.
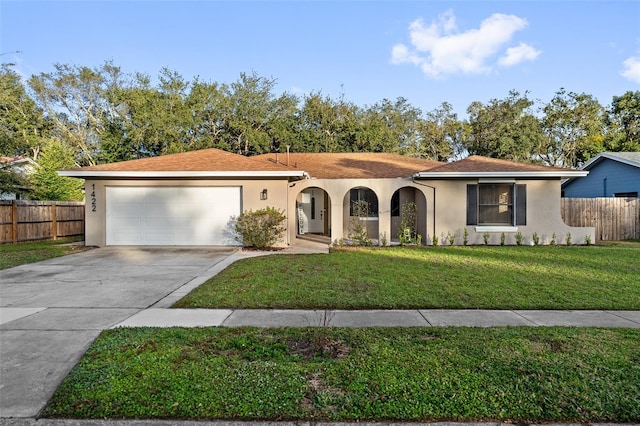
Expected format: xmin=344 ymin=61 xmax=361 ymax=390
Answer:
xmin=43 ymin=327 xmax=640 ymax=423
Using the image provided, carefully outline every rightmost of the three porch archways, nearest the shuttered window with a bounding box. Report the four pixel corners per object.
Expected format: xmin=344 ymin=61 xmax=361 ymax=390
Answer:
xmin=390 ymin=186 xmax=427 ymax=243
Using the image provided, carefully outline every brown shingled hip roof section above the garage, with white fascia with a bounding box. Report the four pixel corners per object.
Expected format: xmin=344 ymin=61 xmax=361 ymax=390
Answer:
xmin=59 ymin=148 xmax=305 ymax=178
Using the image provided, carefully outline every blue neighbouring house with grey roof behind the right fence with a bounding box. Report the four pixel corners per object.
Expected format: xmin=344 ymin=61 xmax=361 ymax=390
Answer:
xmin=562 ymin=152 xmax=640 ymax=198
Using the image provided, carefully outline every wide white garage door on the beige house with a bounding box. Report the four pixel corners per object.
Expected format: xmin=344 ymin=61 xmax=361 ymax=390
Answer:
xmin=106 ymin=186 xmax=240 ymax=246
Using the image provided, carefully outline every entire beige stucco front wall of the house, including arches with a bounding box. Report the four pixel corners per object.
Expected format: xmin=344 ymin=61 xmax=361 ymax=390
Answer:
xmin=85 ymin=178 xmax=595 ymax=246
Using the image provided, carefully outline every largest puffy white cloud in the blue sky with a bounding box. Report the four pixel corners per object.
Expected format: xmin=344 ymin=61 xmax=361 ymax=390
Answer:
xmin=391 ymin=10 xmax=540 ymax=78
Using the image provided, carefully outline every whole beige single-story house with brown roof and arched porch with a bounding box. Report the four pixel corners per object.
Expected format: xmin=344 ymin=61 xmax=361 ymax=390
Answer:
xmin=59 ymin=148 xmax=595 ymax=246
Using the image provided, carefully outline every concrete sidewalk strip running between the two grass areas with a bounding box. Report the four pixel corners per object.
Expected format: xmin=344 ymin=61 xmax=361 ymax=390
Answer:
xmin=112 ymin=309 xmax=640 ymax=328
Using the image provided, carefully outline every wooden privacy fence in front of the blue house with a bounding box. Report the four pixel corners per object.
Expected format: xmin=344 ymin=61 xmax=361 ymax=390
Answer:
xmin=561 ymin=198 xmax=640 ymax=241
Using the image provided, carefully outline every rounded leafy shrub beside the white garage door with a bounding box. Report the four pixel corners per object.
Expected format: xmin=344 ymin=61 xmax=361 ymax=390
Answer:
xmin=236 ymin=207 xmax=286 ymax=249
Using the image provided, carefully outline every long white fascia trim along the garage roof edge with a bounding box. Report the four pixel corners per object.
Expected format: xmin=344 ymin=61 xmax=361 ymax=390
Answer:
xmin=58 ymin=170 xmax=309 ymax=178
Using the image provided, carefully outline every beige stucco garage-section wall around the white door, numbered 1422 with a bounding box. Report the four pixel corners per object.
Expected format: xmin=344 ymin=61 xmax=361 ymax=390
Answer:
xmin=85 ymin=179 xmax=292 ymax=246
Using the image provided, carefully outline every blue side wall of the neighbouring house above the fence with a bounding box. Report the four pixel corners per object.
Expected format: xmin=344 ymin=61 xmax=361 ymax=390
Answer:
xmin=563 ymin=158 xmax=640 ymax=198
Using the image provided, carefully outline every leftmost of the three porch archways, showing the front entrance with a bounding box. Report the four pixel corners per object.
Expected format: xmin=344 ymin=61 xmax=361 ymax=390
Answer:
xmin=296 ymin=187 xmax=331 ymax=237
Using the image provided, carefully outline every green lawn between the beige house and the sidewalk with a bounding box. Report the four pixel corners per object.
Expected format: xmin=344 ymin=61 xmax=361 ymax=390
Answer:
xmin=175 ymin=243 xmax=640 ymax=310
